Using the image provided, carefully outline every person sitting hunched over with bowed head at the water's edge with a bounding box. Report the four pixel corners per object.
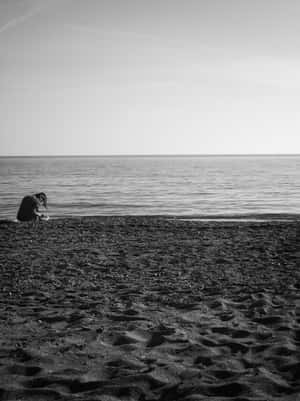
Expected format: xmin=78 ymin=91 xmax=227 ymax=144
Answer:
xmin=17 ymin=192 xmax=47 ymax=221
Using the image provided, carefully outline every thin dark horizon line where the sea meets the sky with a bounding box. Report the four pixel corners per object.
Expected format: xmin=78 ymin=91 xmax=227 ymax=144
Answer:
xmin=0 ymin=153 xmax=300 ymax=158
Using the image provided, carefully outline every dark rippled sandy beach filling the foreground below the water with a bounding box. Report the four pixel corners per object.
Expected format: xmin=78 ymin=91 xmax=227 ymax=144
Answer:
xmin=0 ymin=217 xmax=300 ymax=401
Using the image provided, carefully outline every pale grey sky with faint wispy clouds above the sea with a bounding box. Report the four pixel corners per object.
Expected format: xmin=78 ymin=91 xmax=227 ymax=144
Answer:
xmin=0 ymin=0 xmax=300 ymax=155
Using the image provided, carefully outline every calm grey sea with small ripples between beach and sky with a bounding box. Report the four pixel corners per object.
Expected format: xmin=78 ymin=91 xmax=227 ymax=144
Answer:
xmin=0 ymin=156 xmax=300 ymax=218
